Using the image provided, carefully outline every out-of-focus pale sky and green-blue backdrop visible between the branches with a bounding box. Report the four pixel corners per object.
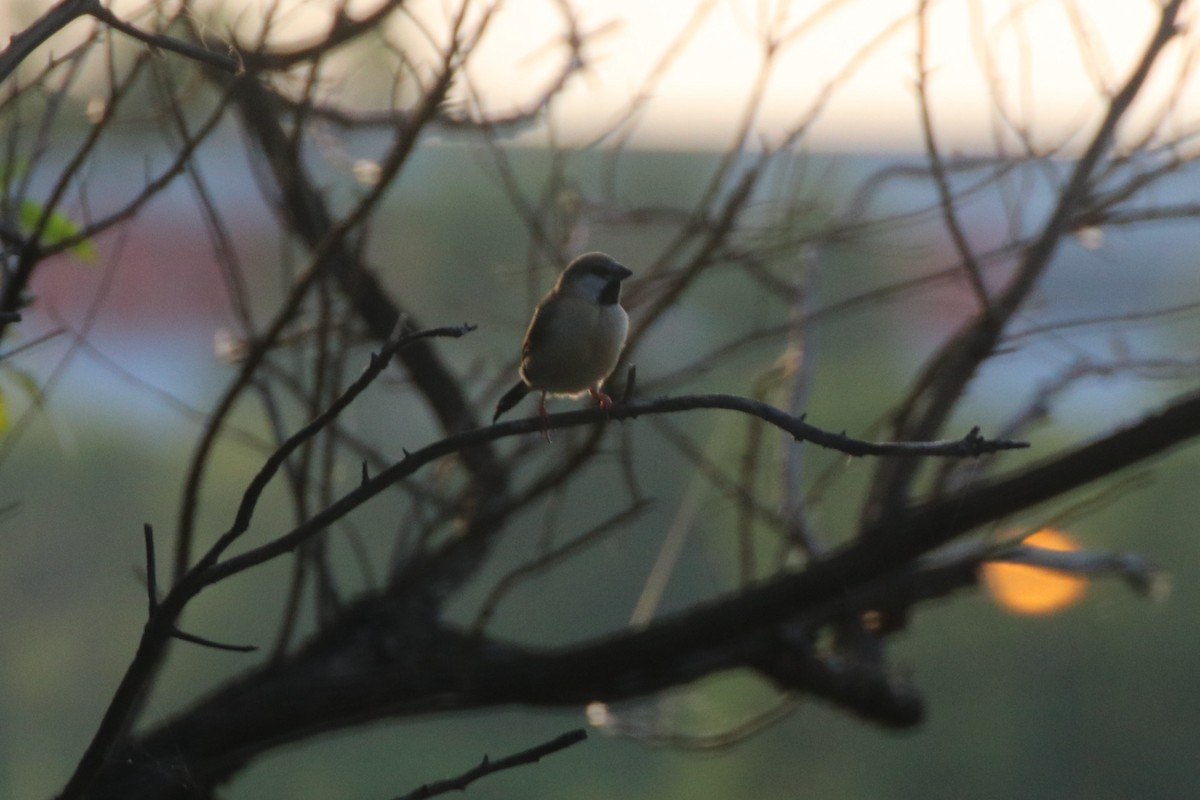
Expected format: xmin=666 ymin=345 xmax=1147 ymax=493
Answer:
xmin=7 ymin=0 xmax=1200 ymax=800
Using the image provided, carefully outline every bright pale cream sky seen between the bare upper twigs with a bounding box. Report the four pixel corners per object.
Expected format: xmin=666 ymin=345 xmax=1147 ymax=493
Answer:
xmin=9 ymin=0 xmax=1200 ymax=151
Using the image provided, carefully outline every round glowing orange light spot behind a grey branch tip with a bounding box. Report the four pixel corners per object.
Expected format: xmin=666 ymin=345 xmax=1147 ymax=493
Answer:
xmin=983 ymin=528 xmax=1087 ymax=614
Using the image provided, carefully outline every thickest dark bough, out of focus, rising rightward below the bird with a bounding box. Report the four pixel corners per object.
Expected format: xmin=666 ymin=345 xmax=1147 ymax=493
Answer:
xmin=84 ymin=383 xmax=1200 ymax=798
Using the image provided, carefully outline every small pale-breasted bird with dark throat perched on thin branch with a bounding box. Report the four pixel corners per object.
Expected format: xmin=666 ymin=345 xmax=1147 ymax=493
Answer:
xmin=492 ymin=253 xmax=632 ymax=441
